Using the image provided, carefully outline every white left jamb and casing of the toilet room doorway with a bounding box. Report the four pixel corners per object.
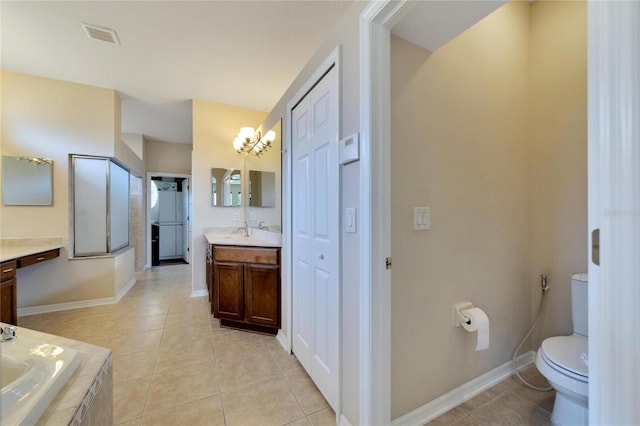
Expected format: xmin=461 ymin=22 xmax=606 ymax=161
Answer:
xmin=359 ymin=0 xmax=418 ymax=425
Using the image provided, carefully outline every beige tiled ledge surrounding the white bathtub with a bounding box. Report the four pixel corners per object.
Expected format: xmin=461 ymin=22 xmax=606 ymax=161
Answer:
xmin=6 ymin=327 xmax=112 ymax=425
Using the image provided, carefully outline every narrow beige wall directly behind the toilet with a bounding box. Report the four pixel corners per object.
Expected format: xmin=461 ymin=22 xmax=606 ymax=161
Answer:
xmin=529 ymin=1 xmax=588 ymax=348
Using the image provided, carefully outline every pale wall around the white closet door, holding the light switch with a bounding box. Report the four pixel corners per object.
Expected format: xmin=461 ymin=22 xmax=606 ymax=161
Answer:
xmin=262 ymin=1 xmax=369 ymax=425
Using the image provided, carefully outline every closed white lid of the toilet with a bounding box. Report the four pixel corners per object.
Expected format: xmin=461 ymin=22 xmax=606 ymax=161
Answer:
xmin=542 ymin=334 xmax=589 ymax=380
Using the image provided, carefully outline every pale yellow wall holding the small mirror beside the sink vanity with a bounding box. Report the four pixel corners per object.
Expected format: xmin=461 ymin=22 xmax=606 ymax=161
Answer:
xmin=191 ymin=99 xmax=267 ymax=292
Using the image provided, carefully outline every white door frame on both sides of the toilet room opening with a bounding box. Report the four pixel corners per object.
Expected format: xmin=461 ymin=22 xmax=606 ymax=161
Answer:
xmin=359 ymin=0 xmax=640 ymax=424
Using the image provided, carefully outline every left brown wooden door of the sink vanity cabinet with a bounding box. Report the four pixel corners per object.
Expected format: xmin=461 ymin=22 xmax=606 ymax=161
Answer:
xmin=213 ymin=262 xmax=244 ymax=321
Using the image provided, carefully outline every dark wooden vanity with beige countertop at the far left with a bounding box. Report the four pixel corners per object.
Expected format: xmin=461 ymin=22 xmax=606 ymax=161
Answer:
xmin=0 ymin=238 xmax=63 ymax=325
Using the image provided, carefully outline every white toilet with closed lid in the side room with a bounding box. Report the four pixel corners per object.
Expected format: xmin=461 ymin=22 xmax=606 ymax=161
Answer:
xmin=536 ymin=274 xmax=589 ymax=425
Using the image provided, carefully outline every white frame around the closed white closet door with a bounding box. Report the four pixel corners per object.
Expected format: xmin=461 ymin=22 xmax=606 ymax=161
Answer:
xmin=276 ymin=45 xmax=342 ymax=416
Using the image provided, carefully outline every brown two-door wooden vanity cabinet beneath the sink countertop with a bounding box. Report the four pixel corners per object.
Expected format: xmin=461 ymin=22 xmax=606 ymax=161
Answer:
xmin=213 ymin=245 xmax=280 ymax=334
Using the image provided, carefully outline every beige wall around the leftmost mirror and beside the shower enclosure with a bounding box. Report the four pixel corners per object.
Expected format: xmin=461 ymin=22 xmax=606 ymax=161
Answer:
xmin=0 ymin=70 xmax=133 ymax=308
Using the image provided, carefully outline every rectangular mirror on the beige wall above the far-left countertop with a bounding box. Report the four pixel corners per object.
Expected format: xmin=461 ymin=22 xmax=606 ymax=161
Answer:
xmin=2 ymin=155 xmax=53 ymax=206
